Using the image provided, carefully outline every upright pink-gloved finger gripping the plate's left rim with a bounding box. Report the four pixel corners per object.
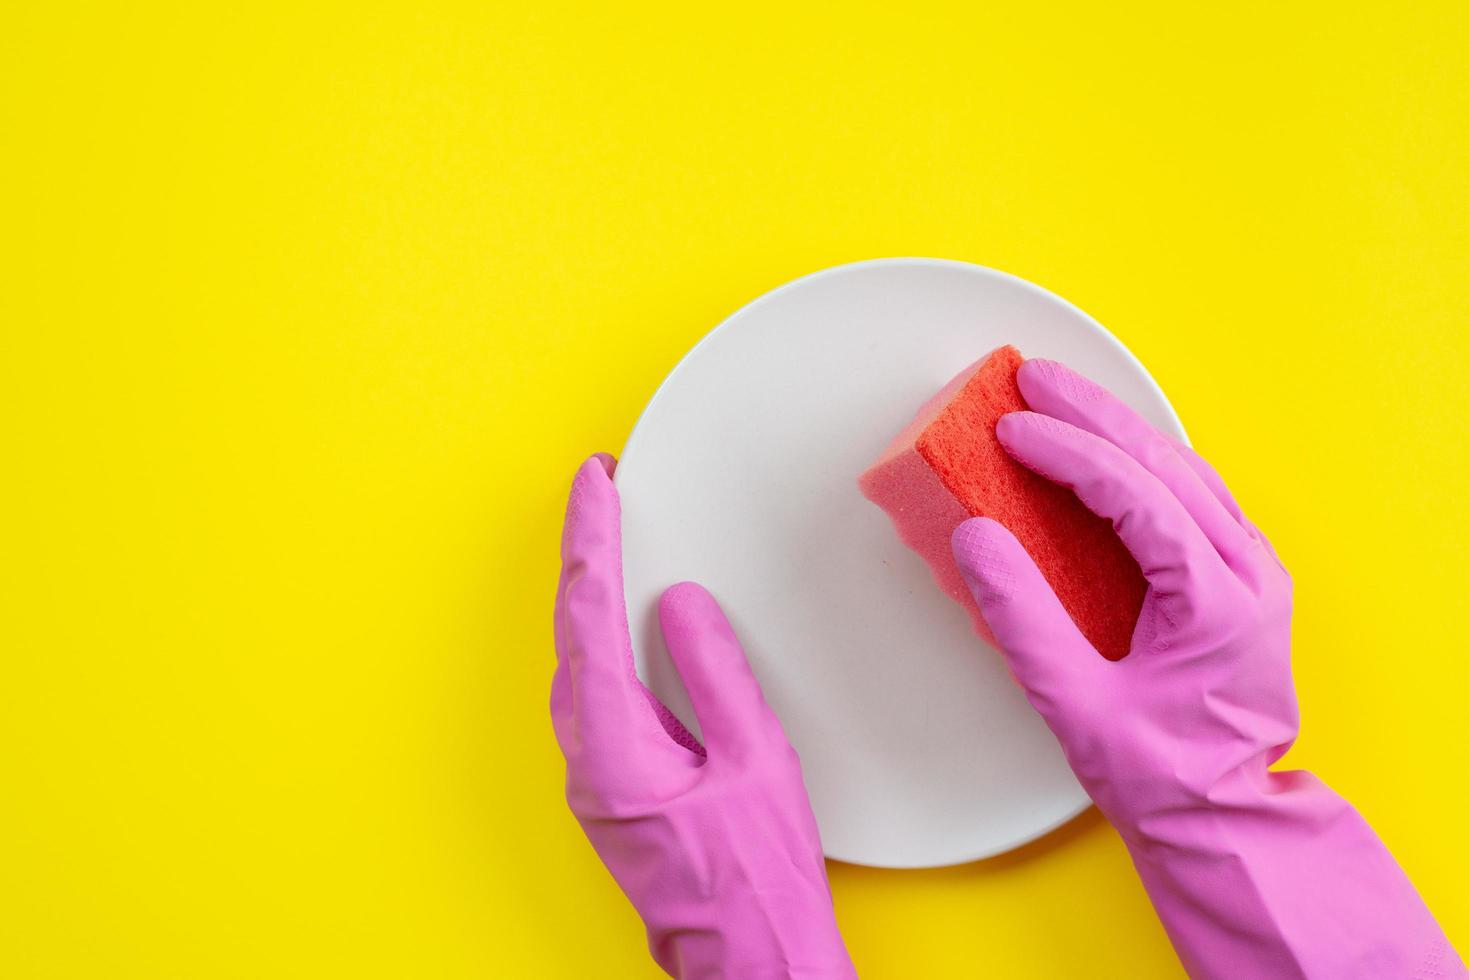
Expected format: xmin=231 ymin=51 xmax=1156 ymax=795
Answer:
xmin=551 ymin=454 xmax=657 ymax=748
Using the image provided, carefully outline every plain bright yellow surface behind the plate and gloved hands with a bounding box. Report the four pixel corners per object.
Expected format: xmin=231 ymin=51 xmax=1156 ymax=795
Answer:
xmin=0 ymin=0 xmax=1469 ymax=980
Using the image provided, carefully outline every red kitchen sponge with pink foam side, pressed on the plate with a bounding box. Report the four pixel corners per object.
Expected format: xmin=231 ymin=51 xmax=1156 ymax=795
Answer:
xmin=858 ymin=347 xmax=1147 ymax=660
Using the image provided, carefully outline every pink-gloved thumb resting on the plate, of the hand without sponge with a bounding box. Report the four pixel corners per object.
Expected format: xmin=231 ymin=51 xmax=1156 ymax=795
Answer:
xmin=658 ymin=582 xmax=784 ymax=761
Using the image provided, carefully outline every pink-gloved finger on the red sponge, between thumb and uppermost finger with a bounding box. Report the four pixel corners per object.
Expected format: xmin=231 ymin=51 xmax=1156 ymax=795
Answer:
xmin=995 ymin=411 xmax=1224 ymax=594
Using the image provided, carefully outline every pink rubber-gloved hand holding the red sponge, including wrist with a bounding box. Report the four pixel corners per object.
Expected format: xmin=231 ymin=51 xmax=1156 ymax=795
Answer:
xmin=952 ymin=360 xmax=1466 ymax=980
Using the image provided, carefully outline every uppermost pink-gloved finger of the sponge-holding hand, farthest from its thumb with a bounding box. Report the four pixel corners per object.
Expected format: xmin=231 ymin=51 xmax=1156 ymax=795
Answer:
xmin=1017 ymin=359 xmax=1255 ymax=570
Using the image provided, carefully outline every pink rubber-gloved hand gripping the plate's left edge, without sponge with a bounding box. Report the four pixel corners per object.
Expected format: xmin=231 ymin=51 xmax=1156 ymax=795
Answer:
xmin=551 ymin=455 xmax=856 ymax=980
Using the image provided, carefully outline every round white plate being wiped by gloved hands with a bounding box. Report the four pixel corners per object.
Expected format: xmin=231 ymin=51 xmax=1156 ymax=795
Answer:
xmin=617 ymin=259 xmax=1183 ymax=867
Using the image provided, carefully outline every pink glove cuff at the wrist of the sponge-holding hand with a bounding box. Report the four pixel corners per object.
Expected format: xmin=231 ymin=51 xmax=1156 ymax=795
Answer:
xmin=1118 ymin=770 xmax=1463 ymax=979
